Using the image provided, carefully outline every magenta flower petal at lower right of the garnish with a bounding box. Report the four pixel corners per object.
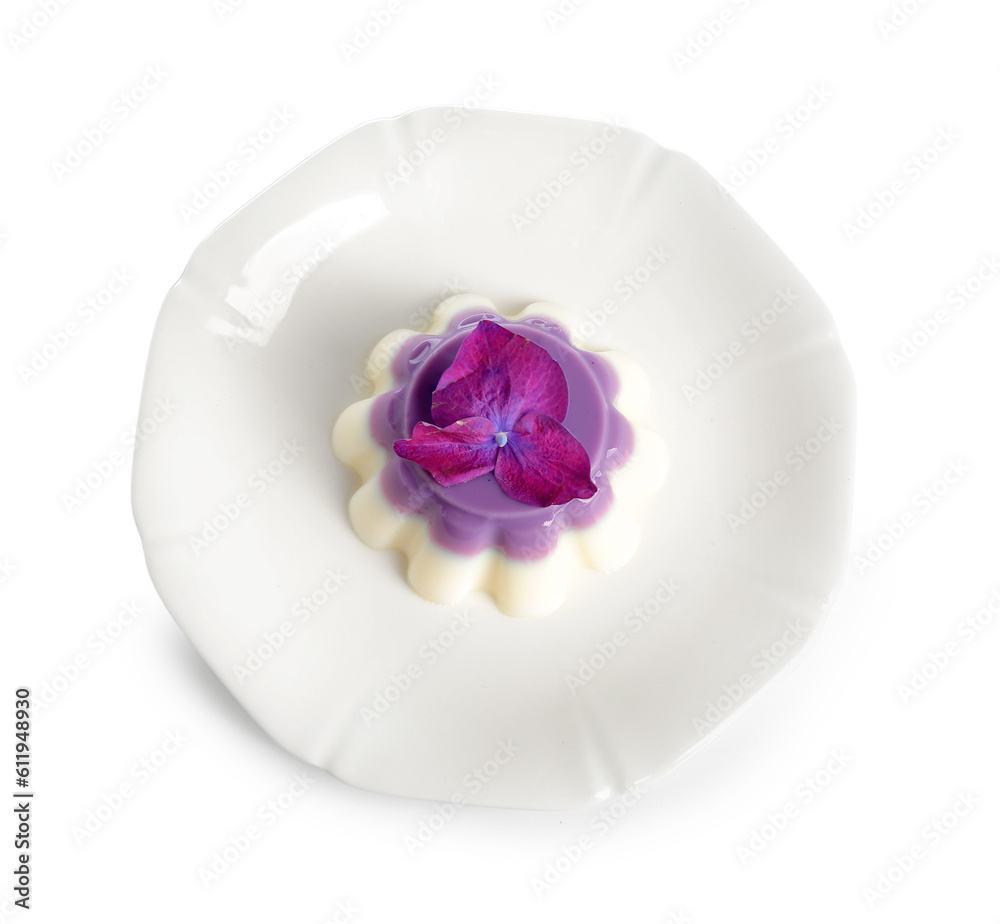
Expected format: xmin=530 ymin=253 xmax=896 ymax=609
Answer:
xmin=494 ymin=411 xmax=597 ymax=507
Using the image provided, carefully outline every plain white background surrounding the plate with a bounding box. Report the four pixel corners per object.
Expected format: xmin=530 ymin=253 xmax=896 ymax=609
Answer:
xmin=0 ymin=0 xmax=1000 ymax=924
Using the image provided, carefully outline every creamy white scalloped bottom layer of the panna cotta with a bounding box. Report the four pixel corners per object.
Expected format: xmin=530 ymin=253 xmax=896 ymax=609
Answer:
xmin=333 ymin=294 xmax=668 ymax=616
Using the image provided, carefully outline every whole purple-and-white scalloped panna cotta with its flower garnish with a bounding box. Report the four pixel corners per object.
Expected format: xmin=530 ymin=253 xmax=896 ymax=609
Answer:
xmin=333 ymin=295 xmax=667 ymax=616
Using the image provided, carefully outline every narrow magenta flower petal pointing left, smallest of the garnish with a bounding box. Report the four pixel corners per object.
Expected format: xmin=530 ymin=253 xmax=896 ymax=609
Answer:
xmin=392 ymin=417 xmax=499 ymax=486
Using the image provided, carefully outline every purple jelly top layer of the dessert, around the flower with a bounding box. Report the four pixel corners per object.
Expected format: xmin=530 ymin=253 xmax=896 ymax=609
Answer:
xmin=371 ymin=310 xmax=633 ymax=561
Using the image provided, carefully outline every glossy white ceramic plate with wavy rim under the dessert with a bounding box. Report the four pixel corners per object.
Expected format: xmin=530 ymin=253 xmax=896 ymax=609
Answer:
xmin=133 ymin=109 xmax=854 ymax=809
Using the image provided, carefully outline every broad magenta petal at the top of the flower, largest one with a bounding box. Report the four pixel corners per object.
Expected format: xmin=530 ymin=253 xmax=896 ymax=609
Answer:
xmin=431 ymin=319 xmax=569 ymax=431
